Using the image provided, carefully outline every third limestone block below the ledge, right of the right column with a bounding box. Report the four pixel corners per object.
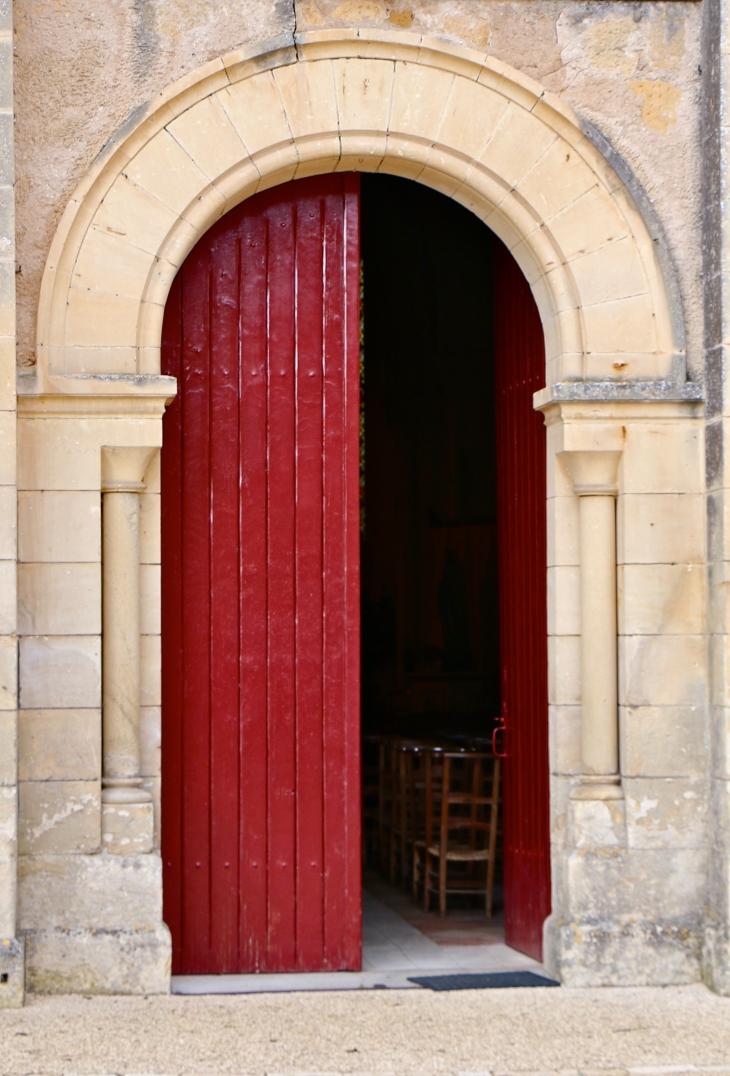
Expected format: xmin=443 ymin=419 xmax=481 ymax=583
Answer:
xmin=618 ymin=564 xmax=706 ymax=635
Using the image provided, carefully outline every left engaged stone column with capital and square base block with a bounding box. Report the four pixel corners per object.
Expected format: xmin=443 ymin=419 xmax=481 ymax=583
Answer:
xmin=101 ymin=448 xmax=154 ymax=855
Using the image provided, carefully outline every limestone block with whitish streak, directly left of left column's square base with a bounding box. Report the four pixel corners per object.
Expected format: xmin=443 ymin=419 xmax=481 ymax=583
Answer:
xmin=18 ymin=781 xmax=101 ymax=855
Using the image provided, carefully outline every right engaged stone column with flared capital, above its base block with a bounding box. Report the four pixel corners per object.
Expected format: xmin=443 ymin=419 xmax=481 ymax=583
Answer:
xmin=560 ymin=451 xmax=623 ymax=799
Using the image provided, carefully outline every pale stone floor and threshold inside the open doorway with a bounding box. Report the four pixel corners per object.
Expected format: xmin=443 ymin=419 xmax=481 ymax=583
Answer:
xmin=172 ymin=877 xmax=543 ymax=994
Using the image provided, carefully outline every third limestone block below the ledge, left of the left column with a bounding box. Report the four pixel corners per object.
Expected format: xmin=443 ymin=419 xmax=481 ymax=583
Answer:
xmin=17 ymin=561 xmax=101 ymax=635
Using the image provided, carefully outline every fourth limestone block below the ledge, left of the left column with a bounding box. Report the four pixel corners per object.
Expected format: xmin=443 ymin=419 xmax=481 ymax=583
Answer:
xmin=20 ymin=635 xmax=101 ymax=710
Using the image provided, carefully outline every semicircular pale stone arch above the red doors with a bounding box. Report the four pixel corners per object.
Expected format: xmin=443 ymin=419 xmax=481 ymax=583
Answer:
xmin=37 ymin=30 xmax=682 ymax=391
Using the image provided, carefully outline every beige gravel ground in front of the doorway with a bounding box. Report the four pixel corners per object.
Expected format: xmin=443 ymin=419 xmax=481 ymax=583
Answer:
xmin=0 ymin=986 xmax=730 ymax=1076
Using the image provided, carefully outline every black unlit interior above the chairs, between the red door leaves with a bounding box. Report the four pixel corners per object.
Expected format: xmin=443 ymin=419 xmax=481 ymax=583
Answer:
xmin=361 ymin=174 xmax=500 ymax=739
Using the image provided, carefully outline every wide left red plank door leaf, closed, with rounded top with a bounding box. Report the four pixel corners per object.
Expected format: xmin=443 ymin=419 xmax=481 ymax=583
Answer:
xmin=162 ymin=174 xmax=361 ymax=974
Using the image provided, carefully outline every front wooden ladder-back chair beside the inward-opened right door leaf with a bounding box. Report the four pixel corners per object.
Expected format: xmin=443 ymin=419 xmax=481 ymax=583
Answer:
xmin=413 ymin=751 xmax=500 ymax=918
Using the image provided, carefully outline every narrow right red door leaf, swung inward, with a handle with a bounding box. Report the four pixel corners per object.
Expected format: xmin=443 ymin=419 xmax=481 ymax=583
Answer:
xmin=494 ymin=243 xmax=550 ymax=960
